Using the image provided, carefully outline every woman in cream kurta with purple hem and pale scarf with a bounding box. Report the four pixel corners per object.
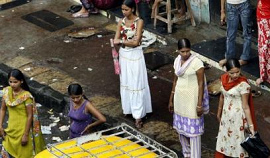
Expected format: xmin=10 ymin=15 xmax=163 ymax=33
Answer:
xmin=169 ymin=38 xmax=209 ymax=158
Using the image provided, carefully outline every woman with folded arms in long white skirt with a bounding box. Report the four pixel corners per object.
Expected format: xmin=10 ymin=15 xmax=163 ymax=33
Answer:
xmin=114 ymin=0 xmax=152 ymax=128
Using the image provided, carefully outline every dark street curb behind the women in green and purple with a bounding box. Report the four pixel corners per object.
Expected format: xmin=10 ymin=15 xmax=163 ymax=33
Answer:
xmin=0 ymin=63 xmax=68 ymax=112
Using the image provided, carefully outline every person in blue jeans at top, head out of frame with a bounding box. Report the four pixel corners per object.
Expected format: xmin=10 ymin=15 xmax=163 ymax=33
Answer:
xmin=219 ymin=0 xmax=251 ymax=67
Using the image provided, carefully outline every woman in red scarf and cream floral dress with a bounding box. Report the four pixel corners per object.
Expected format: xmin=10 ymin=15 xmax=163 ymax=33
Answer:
xmin=215 ymin=59 xmax=256 ymax=158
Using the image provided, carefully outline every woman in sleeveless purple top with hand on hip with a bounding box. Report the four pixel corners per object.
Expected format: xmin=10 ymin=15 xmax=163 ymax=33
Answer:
xmin=68 ymin=84 xmax=106 ymax=138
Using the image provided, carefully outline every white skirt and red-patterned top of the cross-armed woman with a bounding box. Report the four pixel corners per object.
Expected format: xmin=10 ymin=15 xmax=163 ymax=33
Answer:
xmin=119 ymin=18 xmax=152 ymax=119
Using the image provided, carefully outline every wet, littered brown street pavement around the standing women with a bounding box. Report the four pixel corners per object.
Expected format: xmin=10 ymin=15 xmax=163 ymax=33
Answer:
xmin=0 ymin=0 xmax=270 ymax=158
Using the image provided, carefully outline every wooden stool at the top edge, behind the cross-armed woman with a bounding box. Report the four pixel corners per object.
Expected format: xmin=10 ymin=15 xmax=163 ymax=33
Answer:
xmin=152 ymin=0 xmax=196 ymax=33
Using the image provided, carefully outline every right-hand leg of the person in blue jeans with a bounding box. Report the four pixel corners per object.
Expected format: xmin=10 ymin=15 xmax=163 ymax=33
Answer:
xmin=238 ymin=1 xmax=252 ymax=65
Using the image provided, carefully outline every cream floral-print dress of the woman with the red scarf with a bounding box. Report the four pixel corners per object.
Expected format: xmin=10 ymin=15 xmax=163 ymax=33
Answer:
xmin=216 ymin=82 xmax=250 ymax=157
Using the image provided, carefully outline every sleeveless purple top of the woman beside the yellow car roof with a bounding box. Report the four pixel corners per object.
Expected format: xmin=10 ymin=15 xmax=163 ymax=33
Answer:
xmin=68 ymin=100 xmax=92 ymax=138
